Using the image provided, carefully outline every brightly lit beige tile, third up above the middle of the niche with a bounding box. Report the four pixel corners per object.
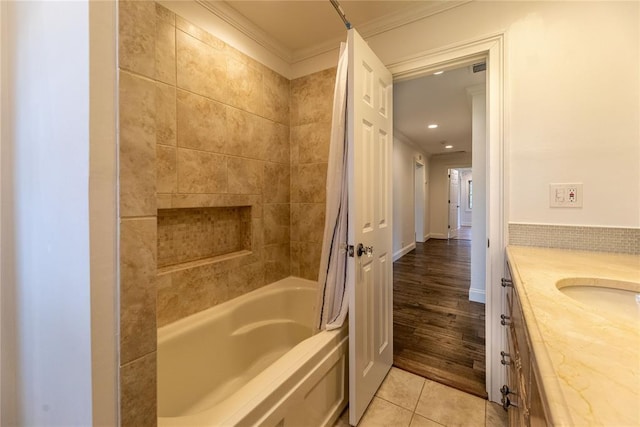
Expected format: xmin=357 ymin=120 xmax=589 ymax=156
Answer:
xmin=176 ymin=29 xmax=228 ymax=102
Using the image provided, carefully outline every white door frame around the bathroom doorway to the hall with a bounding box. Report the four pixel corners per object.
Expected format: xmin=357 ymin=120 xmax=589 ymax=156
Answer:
xmin=387 ymin=32 xmax=508 ymax=402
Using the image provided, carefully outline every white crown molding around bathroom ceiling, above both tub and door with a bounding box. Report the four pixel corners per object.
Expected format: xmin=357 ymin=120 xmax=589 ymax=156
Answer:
xmin=196 ymin=0 xmax=471 ymax=64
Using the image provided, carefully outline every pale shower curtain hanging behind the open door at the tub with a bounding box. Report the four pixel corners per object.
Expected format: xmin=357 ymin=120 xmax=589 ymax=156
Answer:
xmin=316 ymin=43 xmax=353 ymax=330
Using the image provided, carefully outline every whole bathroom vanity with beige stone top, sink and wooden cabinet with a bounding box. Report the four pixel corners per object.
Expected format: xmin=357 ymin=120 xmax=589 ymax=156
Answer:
xmin=501 ymin=246 xmax=640 ymax=426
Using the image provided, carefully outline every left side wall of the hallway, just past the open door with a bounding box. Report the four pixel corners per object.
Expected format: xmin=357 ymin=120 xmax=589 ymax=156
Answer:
xmin=393 ymin=132 xmax=429 ymax=260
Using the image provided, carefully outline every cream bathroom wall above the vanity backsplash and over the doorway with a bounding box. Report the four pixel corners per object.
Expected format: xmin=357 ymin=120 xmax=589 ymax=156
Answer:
xmin=300 ymin=1 xmax=640 ymax=227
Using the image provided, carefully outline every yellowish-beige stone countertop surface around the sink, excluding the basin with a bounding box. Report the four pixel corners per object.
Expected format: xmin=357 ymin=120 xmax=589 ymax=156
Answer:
xmin=507 ymin=246 xmax=640 ymax=426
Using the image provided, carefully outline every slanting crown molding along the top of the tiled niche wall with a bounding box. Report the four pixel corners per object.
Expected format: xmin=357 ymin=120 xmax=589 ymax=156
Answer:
xmin=196 ymin=0 xmax=293 ymax=64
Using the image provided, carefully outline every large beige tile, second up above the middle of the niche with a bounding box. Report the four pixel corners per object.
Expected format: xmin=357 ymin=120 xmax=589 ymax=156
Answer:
xmin=177 ymin=90 xmax=227 ymax=153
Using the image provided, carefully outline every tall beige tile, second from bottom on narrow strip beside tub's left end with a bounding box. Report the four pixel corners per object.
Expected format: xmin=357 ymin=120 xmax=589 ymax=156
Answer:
xmin=120 ymin=217 xmax=156 ymax=364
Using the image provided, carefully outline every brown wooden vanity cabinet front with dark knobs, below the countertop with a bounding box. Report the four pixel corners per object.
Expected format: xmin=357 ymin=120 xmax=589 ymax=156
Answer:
xmin=501 ymin=263 xmax=547 ymax=427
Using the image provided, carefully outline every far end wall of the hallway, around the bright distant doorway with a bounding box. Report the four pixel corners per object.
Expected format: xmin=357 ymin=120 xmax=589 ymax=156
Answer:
xmin=429 ymin=152 xmax=471 ymax=239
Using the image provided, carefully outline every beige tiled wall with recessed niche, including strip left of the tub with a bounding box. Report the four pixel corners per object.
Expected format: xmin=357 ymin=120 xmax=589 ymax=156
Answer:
xmin=119 ymin=2 xmax=291 ymax=426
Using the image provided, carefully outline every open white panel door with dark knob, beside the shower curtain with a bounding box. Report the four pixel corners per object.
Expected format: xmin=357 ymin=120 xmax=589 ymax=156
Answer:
xmin=347 ymin=29 xmax=393 ymax=425
